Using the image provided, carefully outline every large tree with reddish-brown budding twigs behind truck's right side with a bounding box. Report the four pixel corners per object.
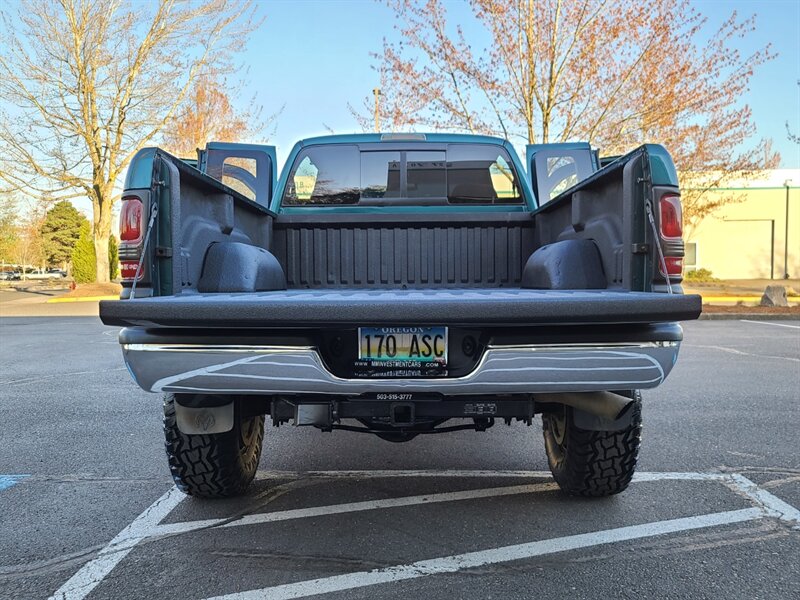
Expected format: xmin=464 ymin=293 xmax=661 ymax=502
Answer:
xmin=370 ymin=0 xmax=779 ymax=234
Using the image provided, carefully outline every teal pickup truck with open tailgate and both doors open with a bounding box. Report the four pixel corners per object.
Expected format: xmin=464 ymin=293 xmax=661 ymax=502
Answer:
xmin=100 ymin=134 xmax=701 ymax=497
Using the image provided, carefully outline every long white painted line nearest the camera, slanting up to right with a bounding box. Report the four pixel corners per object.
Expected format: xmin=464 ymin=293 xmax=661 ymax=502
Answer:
xmin=202 ymin=508 xmax=764 ymax=600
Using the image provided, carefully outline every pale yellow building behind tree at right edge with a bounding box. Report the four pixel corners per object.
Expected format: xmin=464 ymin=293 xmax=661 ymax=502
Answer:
xmin=684 ymin=169 xmax=800 ymax=279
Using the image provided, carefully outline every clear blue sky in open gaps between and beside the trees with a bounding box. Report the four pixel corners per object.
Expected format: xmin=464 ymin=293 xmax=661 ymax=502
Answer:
xmin=242 ymin=0 xmax=800 ymax=168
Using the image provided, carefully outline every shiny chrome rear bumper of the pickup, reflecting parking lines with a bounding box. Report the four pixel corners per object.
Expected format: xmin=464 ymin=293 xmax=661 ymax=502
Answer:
xmin=122 ymin=341 xmax=680 ymax=396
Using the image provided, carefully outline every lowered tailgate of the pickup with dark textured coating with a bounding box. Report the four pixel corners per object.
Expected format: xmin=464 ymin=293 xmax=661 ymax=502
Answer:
xmin=100 ymin=289 xmax=701 ymax=328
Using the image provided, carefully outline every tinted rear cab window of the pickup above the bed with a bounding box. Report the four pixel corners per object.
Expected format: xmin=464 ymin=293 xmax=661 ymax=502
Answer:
xmin=281 ymin=143 xmax=525 ymax=208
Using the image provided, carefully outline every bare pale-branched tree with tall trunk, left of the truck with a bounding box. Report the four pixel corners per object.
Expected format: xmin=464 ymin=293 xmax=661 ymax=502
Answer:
xmin=0 ymin=0 xmax=257 ymax=282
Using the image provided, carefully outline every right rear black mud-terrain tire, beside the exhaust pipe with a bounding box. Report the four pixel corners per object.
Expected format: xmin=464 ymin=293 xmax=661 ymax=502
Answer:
xmin=542 ymin=391 xmax=642 ymax=497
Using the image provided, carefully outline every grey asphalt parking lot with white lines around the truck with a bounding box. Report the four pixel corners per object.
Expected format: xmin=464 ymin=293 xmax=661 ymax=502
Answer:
xmin=0 ymin=317 xmax=800 ymax=600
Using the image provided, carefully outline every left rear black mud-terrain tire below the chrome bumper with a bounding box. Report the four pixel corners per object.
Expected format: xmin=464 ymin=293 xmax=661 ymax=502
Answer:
xmin=164 ymin=394 xmax=264 ymax=498
